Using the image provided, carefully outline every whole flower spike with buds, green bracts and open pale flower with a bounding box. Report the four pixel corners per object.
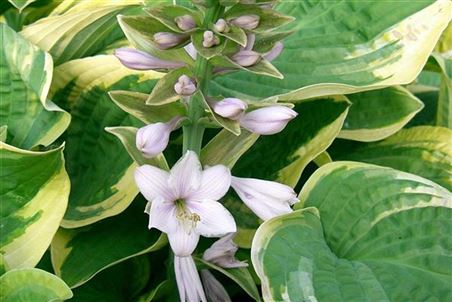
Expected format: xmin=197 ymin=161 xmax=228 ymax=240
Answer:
xmin=115 ymin=0 xmax=298 ymax=302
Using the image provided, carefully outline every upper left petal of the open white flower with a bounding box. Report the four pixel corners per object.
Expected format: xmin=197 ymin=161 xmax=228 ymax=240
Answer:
xmin=135 ymin=165 xmax=172 ymax=201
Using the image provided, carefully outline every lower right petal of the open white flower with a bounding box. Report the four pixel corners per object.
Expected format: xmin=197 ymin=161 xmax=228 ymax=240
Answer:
xmin=186 ymin=200 xmax=237 ymax=237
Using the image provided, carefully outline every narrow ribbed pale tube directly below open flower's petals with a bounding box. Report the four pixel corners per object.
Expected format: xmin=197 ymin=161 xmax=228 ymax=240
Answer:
xmin=174 ymin=256 xmax=207 ymax=302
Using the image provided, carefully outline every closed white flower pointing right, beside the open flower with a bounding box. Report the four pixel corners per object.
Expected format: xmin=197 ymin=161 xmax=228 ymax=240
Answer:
xmin=231 ymin=177 xmax=299 ymax=220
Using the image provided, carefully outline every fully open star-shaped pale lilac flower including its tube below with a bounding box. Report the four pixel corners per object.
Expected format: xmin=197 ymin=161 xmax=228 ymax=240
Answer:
xmin=135 ymin=151 xmax=236 ymax=302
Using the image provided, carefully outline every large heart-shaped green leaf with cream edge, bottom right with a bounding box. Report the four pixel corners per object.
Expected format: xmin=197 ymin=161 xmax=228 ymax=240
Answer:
xmin=251 ymin=162 xmax=452 ymax=302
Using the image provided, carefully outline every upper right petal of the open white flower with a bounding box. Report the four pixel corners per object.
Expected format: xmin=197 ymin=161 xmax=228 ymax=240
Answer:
xmin=188 ymin=165 xmax=231 ymax=201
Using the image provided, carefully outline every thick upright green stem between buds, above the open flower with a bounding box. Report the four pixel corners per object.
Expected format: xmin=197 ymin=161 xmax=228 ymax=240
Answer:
xmin=183 ymin=4 xmax=224 ymax=155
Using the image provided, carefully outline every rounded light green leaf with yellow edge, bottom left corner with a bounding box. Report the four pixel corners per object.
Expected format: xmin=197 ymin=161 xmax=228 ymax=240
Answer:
xmin=0 ymin=268 xmax=72 ymax=302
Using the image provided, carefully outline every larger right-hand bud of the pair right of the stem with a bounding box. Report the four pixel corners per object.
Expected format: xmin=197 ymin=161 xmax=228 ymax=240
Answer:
xmin=240 ymin=105 xmax=298 ymax=135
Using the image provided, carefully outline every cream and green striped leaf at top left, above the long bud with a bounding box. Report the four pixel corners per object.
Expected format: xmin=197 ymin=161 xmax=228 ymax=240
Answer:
xmin=21 ymin=0 xmax=139 ymax=65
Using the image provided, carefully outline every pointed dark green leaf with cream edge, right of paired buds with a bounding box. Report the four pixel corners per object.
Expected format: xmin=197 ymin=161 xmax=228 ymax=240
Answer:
xmin=338 ymin=86 xmax=424 ymax=142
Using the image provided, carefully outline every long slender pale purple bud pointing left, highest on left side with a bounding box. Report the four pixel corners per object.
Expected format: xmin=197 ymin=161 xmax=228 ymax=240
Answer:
xmin=115 ymin=48 xmax=185 ymax=70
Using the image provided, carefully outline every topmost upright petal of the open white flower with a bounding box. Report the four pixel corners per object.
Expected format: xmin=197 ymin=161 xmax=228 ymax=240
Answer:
xmin=168 ymin=150 xmax=201 ymax=199
